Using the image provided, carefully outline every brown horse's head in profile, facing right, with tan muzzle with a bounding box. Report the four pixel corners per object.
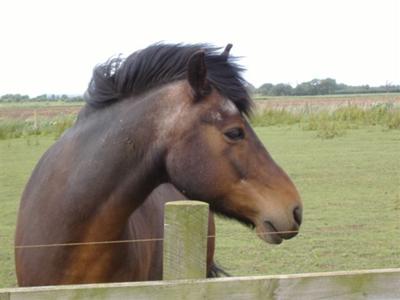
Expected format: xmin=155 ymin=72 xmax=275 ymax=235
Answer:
xmin=166 ymin=45 xmax=302 ymax=244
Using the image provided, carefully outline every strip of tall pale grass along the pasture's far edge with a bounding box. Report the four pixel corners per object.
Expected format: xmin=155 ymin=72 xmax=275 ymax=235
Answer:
xmin=0 ymin=103 xmax=400 ymax=140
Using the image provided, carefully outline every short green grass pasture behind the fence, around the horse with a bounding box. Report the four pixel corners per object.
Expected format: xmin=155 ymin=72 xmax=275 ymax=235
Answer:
xmin=0 ymin=96 xmax=400 ymax=287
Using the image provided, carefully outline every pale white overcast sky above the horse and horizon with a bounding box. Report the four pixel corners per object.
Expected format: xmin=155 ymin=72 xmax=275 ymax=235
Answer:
xmin=0 ymin=0 xmax=400 ymax=96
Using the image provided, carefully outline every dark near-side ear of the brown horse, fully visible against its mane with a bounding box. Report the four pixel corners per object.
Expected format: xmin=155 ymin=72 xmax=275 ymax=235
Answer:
xmin=187 ymin=50 xmax=210 ymax=100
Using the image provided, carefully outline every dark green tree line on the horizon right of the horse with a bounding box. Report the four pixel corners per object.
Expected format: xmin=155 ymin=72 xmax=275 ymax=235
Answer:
xmin=252 ymin=78 xmax=400 ymax=96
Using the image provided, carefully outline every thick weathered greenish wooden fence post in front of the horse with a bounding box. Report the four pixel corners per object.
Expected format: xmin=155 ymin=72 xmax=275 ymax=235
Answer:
xmin=163 ymin=200 xmax=208 ymax=280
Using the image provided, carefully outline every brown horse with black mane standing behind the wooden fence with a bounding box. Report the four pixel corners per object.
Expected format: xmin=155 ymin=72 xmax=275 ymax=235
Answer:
xmin=15 ymin=43 xmax=303 ymax=286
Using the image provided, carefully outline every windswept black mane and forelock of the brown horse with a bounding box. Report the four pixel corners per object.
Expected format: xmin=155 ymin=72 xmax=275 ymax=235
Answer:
xmin=84 ymin=44 xmax=252 ymax=115
